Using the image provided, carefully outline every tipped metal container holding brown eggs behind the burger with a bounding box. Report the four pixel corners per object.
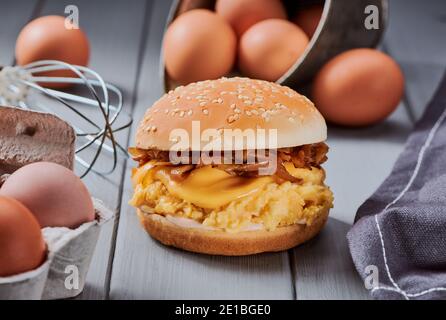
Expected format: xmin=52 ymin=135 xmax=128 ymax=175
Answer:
xmin=161 ymin=0 xmax=388 ymax=92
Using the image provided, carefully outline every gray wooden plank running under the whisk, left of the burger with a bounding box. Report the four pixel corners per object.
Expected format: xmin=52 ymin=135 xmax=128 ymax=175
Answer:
xmin=36 ymin=0 xmax=146 ymax=299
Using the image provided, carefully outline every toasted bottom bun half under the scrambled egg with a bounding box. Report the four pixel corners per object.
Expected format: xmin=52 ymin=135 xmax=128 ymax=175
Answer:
xmin=138 ymin=206 xmax=330 ymax=256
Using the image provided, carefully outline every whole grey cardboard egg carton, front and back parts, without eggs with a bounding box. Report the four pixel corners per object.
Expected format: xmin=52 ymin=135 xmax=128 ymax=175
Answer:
xmin=0 ymin=107 xmax=113 ymax=300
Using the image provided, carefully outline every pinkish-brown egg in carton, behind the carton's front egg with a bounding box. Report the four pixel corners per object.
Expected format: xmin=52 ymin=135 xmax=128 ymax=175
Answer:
xmin=0 ymin=162 xmax=95 ymax=228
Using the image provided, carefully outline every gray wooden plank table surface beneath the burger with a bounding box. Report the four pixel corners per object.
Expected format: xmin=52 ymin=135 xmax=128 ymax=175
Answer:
xmin=0 ymin=0 xmax=446 ymax=299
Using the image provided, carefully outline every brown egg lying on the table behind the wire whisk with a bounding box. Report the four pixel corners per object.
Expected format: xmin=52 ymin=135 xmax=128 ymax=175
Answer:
xmin=15 ymin=16 xmax=90 ymax=87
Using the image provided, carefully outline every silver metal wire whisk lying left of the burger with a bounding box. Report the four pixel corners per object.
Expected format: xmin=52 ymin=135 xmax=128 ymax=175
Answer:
xmin=0 ymin=60 xmax=132 ymax=178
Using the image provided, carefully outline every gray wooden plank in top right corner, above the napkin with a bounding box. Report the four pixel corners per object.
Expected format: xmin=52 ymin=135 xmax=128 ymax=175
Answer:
xmin=386 ymin=0 xmax=446 ymax=119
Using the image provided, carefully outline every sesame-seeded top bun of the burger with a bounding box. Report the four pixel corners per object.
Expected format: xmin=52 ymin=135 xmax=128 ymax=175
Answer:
xmin=136 ymin=78 xmax=327 ymax=150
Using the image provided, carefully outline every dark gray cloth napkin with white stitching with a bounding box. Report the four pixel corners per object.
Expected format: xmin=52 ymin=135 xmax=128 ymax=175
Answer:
xmin=347 ymin=76 xmax=446 ymax=299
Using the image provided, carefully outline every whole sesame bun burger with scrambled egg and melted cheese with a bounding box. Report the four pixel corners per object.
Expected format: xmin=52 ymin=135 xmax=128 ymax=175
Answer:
xmin=129 ymin=78 xmax=333 ymax=256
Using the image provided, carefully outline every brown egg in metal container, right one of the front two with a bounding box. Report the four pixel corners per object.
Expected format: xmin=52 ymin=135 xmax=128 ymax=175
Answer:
xmin=239 ymin=19 xmax=308 ymax=81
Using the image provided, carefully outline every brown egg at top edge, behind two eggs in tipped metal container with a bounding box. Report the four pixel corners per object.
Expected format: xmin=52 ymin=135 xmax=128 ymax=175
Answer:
xmin=215 ymin=0 xmax=287 ymax=37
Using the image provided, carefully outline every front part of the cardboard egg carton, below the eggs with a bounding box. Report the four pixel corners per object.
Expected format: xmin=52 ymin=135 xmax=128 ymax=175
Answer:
xmin=0 ymin=199 xmax=113 ymax=300
